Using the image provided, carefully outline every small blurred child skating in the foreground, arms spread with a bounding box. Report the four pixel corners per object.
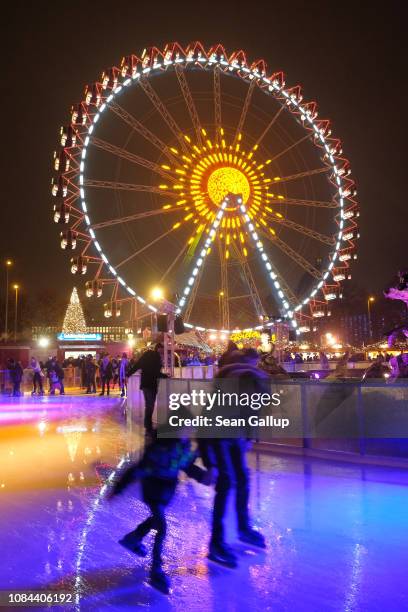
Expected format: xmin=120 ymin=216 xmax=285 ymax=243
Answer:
xmin=110 ymin=438 xmax=213 ymax=594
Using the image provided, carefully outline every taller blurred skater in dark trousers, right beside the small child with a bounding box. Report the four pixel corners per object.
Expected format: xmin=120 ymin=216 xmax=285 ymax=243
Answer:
xmin=198 ymin=351 xmax=270 ymax=567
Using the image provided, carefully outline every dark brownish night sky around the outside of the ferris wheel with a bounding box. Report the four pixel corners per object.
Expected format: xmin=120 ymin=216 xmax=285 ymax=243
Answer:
xmin=0 ymin=1 xmax=408 ymax=308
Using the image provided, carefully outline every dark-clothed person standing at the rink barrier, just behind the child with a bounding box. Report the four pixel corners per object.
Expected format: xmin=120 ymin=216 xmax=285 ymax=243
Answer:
xmin=128 ymin=343 xmax=167 ymax=435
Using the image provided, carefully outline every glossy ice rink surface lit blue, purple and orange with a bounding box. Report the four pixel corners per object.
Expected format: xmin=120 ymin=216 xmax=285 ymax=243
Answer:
xmin=0 ymin=396 xmax=408 ymax=612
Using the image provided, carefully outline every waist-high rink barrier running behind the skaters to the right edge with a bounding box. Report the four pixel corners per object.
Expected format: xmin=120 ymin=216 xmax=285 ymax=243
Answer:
xmin=128 ymin=375 xmax=408 ymax=467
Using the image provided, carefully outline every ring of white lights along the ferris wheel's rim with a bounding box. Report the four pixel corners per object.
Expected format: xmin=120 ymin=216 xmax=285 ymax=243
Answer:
xmin=55 ymin=43 xmax=356 ymax=333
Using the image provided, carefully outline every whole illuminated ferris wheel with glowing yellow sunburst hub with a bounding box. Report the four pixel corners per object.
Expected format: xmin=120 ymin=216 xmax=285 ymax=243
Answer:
xmin=52 ymin=42 xmax=358 ymax=332
